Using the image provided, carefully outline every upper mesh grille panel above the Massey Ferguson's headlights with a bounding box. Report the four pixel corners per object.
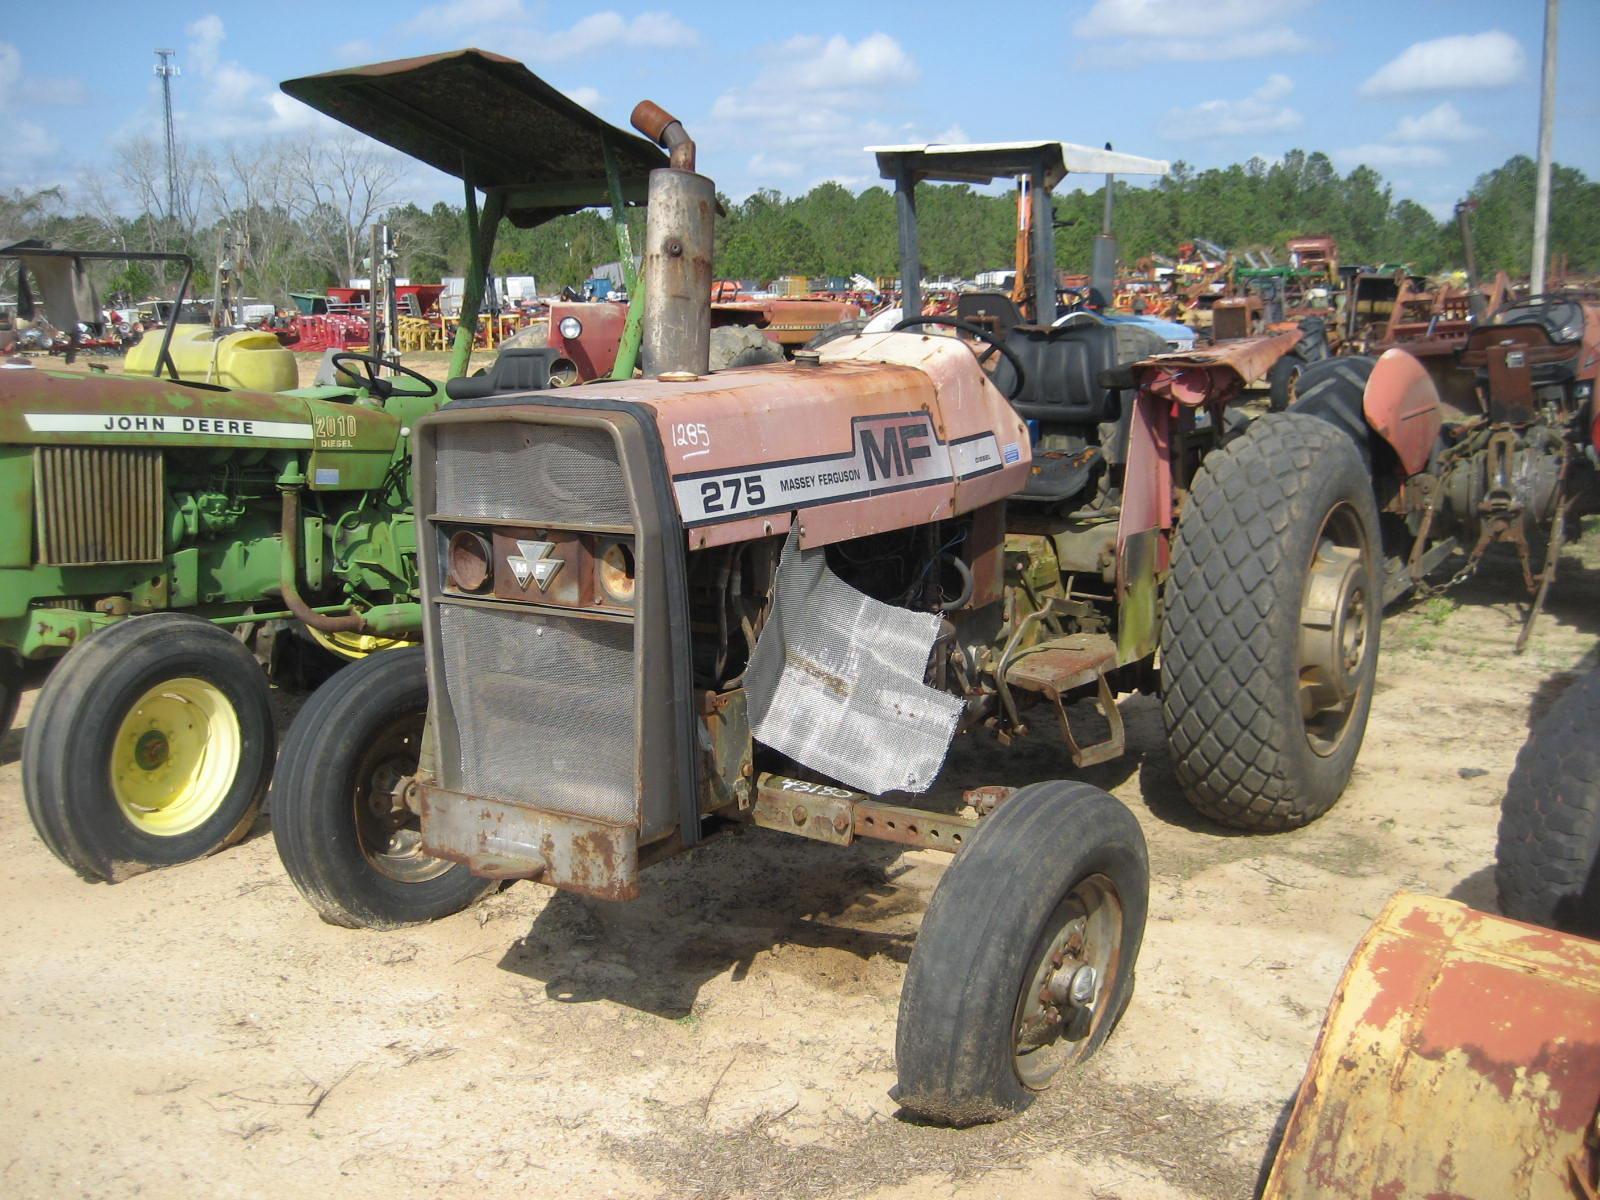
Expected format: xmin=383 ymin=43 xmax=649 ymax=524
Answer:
xmin=435 ymin=421 xmax=634 ymax=525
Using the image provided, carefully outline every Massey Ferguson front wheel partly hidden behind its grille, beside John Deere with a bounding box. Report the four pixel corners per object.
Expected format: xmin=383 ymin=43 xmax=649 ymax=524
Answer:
xmin=270 ymin=646 xmax=494 ymax=930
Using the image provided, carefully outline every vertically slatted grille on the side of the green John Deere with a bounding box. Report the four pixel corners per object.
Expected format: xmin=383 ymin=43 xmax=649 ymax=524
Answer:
xmin=34 ymin=446 xmax=163 ymax=566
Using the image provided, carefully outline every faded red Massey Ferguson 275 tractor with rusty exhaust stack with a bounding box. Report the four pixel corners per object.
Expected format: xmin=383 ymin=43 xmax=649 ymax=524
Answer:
xmin=270 ymin=51 xmax=1408 ymax=1125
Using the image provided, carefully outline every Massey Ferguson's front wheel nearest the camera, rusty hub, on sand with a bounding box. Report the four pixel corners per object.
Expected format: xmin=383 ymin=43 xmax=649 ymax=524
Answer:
xmin=894 ymin=781 xmax=1150 ymax=1126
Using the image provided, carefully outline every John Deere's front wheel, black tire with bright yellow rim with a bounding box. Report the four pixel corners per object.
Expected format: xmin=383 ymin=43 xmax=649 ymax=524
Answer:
xmin=22 ymin=613 xmax=277 ymax=883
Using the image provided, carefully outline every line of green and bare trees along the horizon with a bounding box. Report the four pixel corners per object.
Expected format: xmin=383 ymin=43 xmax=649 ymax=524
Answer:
xmin=0 ymin=139 xmax=1600 ymax=304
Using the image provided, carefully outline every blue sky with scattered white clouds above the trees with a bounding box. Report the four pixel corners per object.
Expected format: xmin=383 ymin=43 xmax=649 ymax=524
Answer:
xmin=0 ymin=0 xmax=1600 ymax=222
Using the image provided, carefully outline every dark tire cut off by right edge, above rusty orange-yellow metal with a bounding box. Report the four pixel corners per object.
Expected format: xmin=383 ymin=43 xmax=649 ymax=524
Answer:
xmin=1494 ymin=670 xmax=1600 ymax=938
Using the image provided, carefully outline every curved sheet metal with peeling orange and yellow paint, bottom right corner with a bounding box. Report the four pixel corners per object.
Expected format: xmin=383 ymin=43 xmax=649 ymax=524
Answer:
xmin=1262 ymin=893 xmax=1600 ymax=1200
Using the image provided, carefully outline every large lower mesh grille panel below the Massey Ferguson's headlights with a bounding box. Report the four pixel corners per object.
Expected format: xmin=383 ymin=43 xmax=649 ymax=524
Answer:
xmin=438 ymin=605 xmax=638 ymax=822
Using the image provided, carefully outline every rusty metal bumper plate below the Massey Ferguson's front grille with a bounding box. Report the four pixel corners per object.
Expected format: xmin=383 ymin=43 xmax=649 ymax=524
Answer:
xmin=421 ymin=786 xmax=638 ymax=899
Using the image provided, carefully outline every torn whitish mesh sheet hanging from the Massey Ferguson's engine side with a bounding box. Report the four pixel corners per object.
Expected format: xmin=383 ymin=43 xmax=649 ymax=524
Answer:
xmin=744 ymin=531 xmax=962 ymax=792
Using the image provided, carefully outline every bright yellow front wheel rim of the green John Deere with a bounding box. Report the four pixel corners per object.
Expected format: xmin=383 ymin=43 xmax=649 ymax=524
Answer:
xmin=110 ymin=678 xmax=243 ymax=837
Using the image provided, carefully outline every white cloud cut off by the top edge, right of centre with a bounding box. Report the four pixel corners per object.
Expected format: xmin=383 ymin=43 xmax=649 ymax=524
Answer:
xmin=1072 ymin=0 xmax=1312 ymax=62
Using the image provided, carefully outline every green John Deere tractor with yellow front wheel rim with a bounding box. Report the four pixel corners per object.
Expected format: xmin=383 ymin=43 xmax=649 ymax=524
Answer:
xmin=0 ymin=64 xmax=666 ymax=880
